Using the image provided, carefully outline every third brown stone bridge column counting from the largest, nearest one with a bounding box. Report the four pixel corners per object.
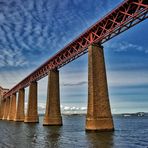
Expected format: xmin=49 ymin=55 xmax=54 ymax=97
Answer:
xmin=24 ymin=82 xmax=39 ymax=122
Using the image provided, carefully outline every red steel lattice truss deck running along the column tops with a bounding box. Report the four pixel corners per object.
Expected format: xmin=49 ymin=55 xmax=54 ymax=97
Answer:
xmin=4 ymin=0 xmax=148 ymax=98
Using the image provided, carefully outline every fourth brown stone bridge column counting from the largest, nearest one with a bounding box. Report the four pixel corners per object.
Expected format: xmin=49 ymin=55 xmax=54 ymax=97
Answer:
xmin=14 ymin=88 xmax=25 ymax=121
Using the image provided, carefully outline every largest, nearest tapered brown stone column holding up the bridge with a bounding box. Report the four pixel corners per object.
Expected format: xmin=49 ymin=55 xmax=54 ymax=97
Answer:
xmin=86 ymin=45 xmax=114 ymax=131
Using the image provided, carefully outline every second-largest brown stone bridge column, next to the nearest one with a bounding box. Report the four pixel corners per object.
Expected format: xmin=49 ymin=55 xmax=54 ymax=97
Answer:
xmin=43 ymin=70 xmax=62 ymax=125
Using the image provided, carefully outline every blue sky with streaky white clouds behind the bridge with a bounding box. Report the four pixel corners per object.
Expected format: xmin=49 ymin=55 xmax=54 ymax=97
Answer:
xmin=0 ymin=0 xmax=148 ymax=113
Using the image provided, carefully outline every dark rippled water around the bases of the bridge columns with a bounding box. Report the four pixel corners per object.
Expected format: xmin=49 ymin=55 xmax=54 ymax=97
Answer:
xmin=0 ymin=115 xmax=148 ymax=148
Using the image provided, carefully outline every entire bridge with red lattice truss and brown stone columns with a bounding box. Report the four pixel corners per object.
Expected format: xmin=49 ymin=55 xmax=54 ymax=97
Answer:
xmin=0 ymin=0 xmax=148 ymax=131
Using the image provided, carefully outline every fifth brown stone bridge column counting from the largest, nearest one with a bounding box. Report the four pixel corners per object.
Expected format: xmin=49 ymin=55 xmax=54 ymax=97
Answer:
xmin=7 ymin=93 xmax=16 ymax=120
